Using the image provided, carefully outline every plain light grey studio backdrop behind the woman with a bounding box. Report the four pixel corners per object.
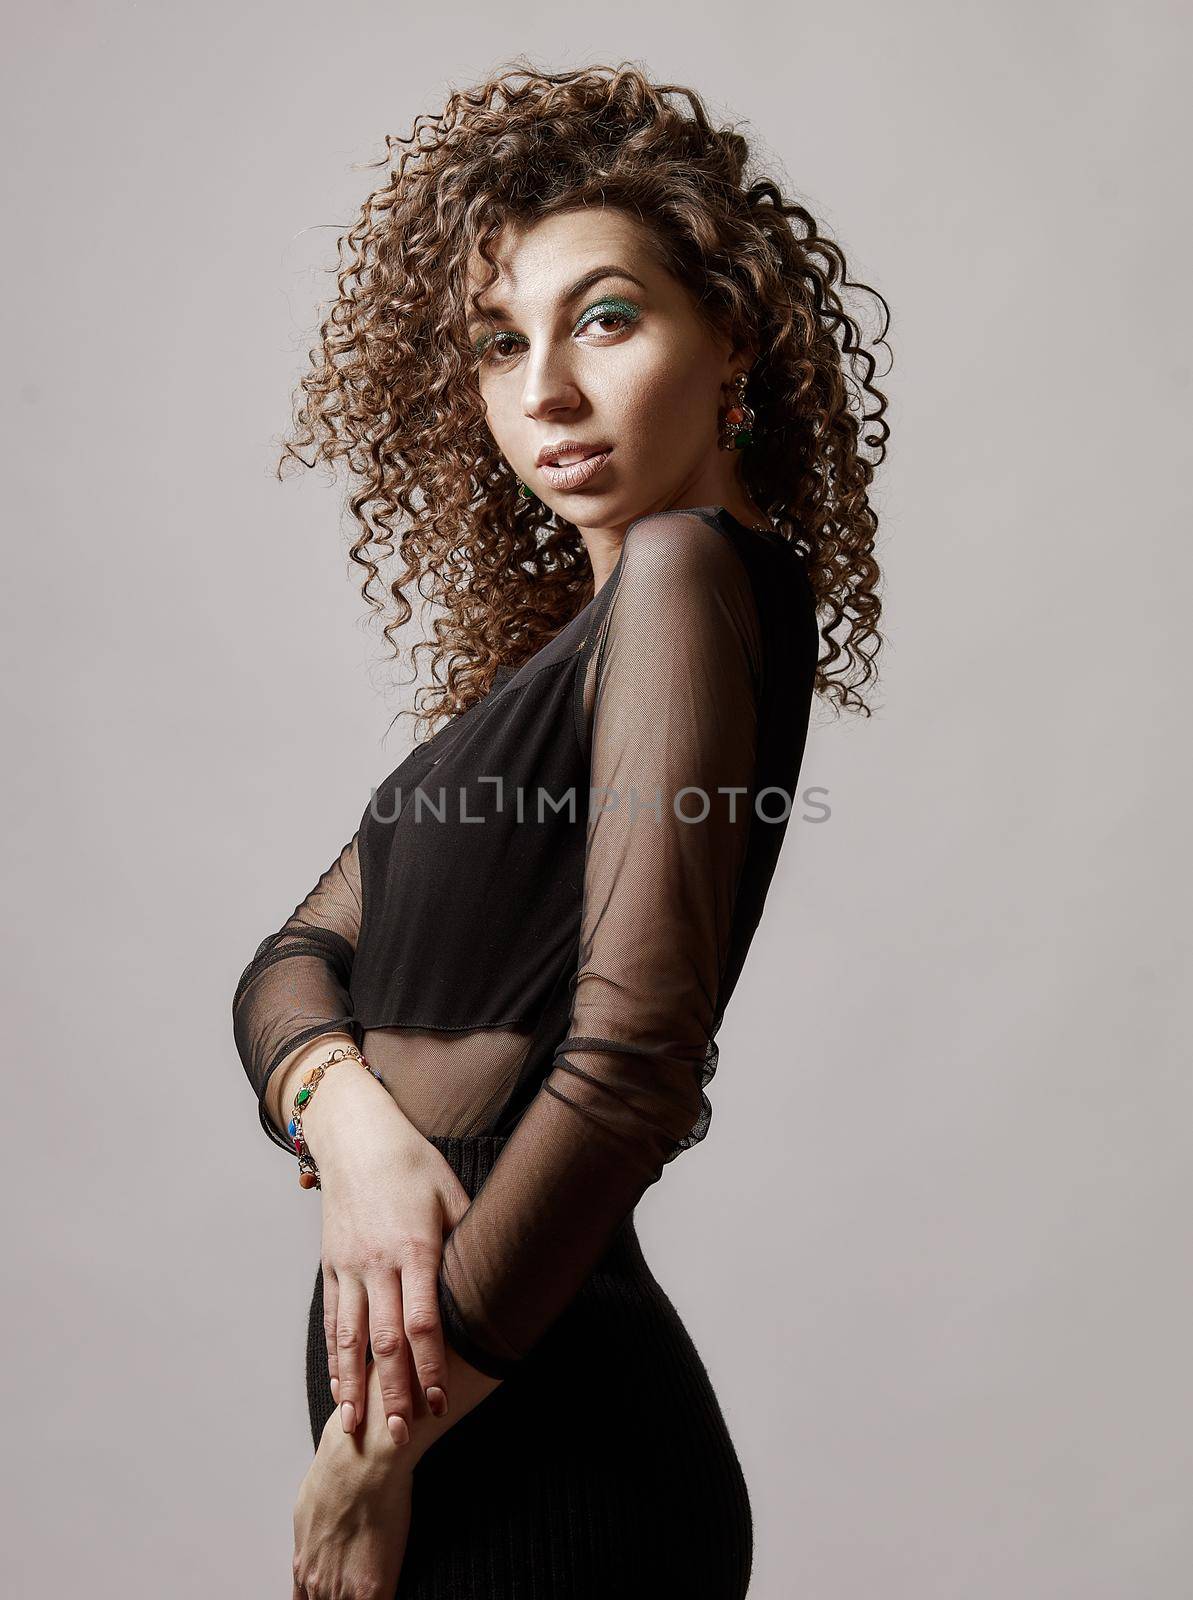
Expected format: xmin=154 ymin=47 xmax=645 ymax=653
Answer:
xmin=0 ymin=0 xmax=1193 ymax=1600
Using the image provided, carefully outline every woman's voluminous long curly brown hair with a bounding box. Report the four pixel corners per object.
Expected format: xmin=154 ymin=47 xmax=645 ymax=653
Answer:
xmin=277 ymin=56 xmax=889 ymax=742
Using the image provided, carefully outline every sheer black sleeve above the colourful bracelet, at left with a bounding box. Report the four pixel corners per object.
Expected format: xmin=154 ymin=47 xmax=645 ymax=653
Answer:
xmin=232 ymin=830 xmax=361 ymax=1155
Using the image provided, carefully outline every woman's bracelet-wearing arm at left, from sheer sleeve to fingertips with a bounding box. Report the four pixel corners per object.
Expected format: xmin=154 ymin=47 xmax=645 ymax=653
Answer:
xmin=232 ymin=834 xmax=469 ymax=1437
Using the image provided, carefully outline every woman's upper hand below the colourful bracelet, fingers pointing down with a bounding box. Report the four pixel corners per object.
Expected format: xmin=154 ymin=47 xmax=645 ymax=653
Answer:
xmin=302 ymin=1064 xmax=472 ymax=1445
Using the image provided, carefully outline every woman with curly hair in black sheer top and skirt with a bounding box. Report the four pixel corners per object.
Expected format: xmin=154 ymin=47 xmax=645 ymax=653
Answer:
xmin=233 ymin=62 xmax=886 ymax=1600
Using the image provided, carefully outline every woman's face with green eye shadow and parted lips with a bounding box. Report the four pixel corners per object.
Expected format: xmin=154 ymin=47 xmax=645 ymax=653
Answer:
xmin=469 ymin=210 xmax=748 ymax=556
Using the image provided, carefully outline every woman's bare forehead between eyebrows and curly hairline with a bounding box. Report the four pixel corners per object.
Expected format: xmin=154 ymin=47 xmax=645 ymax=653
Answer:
xmin=467 ymin=206 xmax=657 ymax=304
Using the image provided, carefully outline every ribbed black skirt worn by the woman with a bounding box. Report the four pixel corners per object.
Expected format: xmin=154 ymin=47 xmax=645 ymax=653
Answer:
xmin=307 ymin=1134 xmax=753 ymax=1600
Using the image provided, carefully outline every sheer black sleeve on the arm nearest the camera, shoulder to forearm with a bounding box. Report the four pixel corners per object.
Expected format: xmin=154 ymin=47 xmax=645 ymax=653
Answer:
xmin=440 ymin=512 xmax=761 ymax=1378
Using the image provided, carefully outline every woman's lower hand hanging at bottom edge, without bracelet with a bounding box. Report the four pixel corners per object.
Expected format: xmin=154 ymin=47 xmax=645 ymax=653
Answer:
xmin=291 ymin=1363 xmax=414 ymax=1600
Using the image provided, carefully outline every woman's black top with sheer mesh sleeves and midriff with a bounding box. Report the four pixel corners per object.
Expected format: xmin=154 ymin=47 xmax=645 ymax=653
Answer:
xmin=232 ymin=507 xmax=819 ymax=1376
